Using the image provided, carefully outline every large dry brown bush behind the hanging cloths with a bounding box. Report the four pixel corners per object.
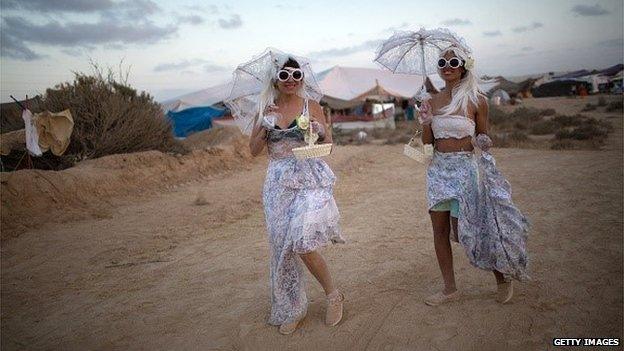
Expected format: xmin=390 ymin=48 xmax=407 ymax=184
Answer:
xmin=3 ymin=64 xmax=186 ymax=170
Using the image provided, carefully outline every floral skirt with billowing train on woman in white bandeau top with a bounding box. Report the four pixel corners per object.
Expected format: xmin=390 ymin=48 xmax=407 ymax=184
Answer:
xmin=427 ymin=151 xmax=529 ymax=280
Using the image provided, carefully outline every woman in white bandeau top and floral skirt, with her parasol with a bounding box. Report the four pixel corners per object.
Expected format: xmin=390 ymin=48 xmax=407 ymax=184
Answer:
xmin=378 ymin=29 xmax=529 ymax=306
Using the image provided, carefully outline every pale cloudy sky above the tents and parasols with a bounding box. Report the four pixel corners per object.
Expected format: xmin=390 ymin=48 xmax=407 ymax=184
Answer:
xmin=0 ymin=0 xmax=624 ymax=102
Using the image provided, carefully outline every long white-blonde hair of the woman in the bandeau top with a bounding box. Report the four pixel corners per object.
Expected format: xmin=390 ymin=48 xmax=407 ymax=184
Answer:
xmin=440 ymin=45 xmax=491 ymax=115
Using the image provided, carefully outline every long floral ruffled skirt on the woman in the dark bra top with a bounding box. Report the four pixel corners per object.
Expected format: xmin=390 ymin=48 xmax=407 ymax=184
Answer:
xmin=263 ymin=157 xmax=344 ymax=325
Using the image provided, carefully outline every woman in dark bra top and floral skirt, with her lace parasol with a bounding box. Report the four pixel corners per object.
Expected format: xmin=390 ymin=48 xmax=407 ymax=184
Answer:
xmin=225 ymin=49 xmax=344 ymax=334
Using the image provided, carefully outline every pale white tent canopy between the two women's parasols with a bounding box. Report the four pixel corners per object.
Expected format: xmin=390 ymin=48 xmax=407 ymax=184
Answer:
xmin=318 ymin=66 xmax=422 ymax=109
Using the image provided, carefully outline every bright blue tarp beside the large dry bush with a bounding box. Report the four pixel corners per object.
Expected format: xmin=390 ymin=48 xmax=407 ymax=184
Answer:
xmin=167 ymin=107 xmax=225 ymax=138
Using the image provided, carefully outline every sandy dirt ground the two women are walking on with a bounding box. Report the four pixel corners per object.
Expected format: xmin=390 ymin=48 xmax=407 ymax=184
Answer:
xmin=1 ymin=99 xmax=623 ymax=350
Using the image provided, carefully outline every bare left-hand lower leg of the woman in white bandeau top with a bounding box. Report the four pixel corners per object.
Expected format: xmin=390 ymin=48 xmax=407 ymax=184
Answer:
xmin=429 ymin=211 xmax=457 ymax=295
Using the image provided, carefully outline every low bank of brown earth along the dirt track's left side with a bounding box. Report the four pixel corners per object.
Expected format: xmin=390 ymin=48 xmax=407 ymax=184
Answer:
xmin=0 ymin=131 xmax=252 ymax=240
